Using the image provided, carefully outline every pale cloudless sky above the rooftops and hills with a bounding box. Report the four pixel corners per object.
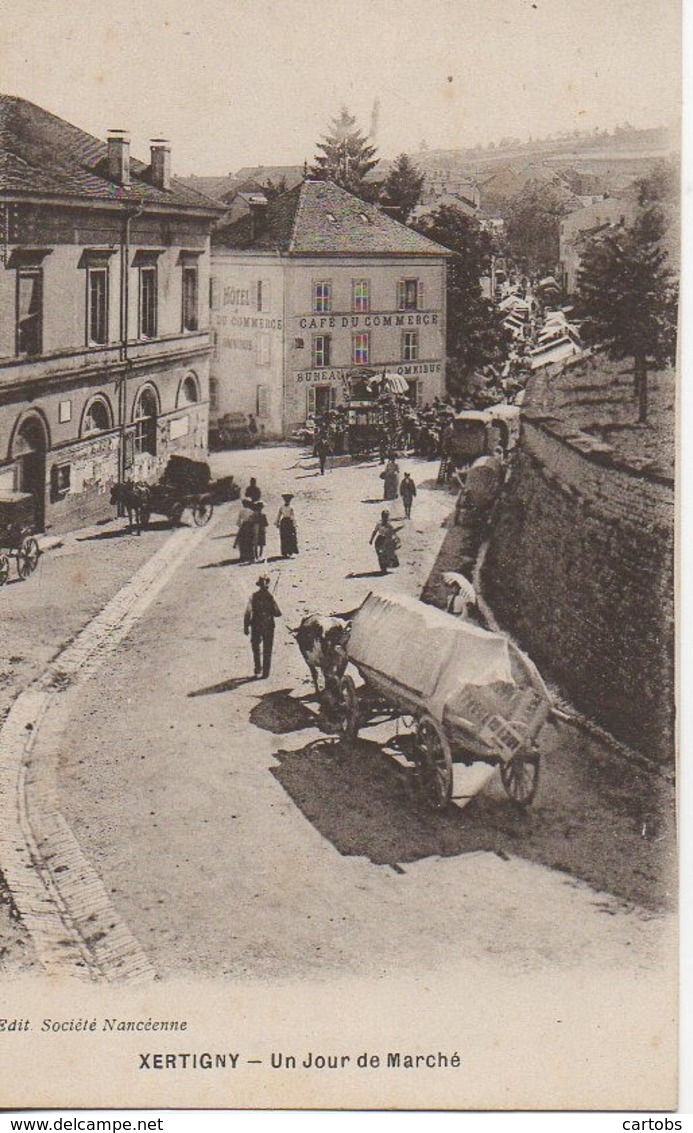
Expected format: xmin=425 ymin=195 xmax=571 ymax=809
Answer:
xmin=0 ymin=0 xmax=681 ymax=176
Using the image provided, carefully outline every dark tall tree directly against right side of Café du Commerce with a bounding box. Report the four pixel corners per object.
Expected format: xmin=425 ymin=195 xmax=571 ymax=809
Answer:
xmin=417 ymin=205 xmax=512 ymax=394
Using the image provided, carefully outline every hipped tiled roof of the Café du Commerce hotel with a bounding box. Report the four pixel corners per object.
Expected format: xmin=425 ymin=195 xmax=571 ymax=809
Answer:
xmin=212 ymin=181 xmax=451 ymax=256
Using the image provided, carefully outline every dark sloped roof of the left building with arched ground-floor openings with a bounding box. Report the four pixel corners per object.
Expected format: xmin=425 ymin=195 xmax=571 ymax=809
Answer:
xmin=0 ymin=94 xmax=216 ymax=211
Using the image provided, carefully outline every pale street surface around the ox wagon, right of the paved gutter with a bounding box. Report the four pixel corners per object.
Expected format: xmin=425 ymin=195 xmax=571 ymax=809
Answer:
xmin=41 ymin=449 xmax=670 ymax=978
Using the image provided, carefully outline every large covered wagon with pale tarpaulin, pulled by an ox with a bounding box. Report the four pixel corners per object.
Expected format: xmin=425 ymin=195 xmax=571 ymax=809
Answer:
xmin=330 ymin=594 xmax=551 ymax=810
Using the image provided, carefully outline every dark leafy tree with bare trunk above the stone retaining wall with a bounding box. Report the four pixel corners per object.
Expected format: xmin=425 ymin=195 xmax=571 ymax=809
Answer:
xmin=578 ymin=206 xmax=678 ymax=424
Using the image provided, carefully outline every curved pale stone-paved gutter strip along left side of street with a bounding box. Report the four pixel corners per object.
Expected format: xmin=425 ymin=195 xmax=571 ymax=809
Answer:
xmin=0 ymin=520 xmax=219 ymax=983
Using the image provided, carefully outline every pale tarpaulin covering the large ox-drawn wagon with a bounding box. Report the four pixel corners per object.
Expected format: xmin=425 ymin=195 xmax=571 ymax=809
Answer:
xmin=349 ymin=594 xmax=514 ymax=719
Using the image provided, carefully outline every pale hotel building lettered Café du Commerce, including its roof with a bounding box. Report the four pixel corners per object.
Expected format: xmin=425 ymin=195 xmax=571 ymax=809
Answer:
xmin=211 ymin=180 xmax=450 ymax=436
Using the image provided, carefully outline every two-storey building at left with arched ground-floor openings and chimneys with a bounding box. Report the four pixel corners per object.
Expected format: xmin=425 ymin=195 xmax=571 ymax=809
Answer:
xmin=0 ymin=95 xmax=222 ymax=530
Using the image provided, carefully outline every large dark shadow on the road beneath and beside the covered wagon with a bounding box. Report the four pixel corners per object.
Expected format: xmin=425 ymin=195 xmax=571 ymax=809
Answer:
xmin=272 ymin=720 xmax=676 ymax=911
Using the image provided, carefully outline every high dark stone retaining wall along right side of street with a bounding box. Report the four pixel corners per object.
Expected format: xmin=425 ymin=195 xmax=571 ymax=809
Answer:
xmin=482 ymin=386 xmax=675 ymax=761
